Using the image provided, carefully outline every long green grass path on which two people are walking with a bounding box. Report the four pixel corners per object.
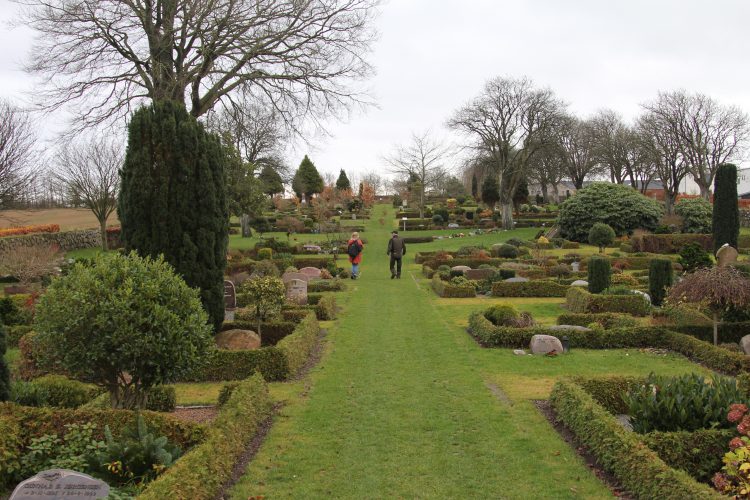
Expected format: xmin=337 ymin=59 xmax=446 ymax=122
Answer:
xmin=233 ymin=206 xmax=610 ymax=499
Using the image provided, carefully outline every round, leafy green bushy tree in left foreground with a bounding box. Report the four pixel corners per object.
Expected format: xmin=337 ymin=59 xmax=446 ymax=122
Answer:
xmin=35 ymin=252 xmax=211 ymax=409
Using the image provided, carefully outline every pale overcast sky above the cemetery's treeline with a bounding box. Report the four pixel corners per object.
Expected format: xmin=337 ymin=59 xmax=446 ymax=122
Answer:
xmin=0 ymin=0 xmax=750 ymax=181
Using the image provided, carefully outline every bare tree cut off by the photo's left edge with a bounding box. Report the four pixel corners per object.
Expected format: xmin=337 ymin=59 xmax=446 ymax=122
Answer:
xmin=0 ymin=100 xmax=36 ymax=209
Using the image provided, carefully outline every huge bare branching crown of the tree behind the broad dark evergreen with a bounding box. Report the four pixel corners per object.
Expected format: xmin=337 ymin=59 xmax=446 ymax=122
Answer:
xmin=16 ymin=0 xmax=378 ymax=129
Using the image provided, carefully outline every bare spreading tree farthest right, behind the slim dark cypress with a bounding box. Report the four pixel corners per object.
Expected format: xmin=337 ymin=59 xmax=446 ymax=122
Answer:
xmin=643 ymin=90 xmax=750 ymax=199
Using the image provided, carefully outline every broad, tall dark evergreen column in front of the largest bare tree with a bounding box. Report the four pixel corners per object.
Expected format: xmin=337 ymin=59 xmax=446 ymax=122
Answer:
xmin=118 ymin=101 xmax=229 ymax=330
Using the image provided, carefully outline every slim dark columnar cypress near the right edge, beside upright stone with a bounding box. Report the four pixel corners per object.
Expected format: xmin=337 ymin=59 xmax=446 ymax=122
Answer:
xmin=713 ymin=163 xmax=740 ymax=252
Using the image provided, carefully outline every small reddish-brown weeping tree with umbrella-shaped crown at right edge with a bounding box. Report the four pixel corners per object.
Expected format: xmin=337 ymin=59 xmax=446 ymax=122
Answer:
xmin=667 ymin=266 xmax=750 ymax=344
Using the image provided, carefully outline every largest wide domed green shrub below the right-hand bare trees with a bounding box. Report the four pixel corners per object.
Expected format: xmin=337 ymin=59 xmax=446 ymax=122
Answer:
xmin=558 ymin=182 xmax=663 ymax=242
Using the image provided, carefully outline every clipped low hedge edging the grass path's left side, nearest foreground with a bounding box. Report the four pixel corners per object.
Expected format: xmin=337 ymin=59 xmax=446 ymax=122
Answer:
xmin=137 ymin=374 xmax=273 ymax=500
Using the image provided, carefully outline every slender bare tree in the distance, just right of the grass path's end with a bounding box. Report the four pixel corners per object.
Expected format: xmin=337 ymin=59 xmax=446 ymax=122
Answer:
xmin=384 ymin=131 xmax=452 ymax=218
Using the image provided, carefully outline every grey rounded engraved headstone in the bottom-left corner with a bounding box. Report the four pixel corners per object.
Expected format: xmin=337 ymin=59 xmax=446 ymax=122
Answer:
xmin=10 ymin=469 xmax=109 ymax=500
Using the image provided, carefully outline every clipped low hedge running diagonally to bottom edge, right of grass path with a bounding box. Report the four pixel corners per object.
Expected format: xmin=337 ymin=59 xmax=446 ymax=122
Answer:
xmin=550 ymin=380 xmax=725 ymax=499
